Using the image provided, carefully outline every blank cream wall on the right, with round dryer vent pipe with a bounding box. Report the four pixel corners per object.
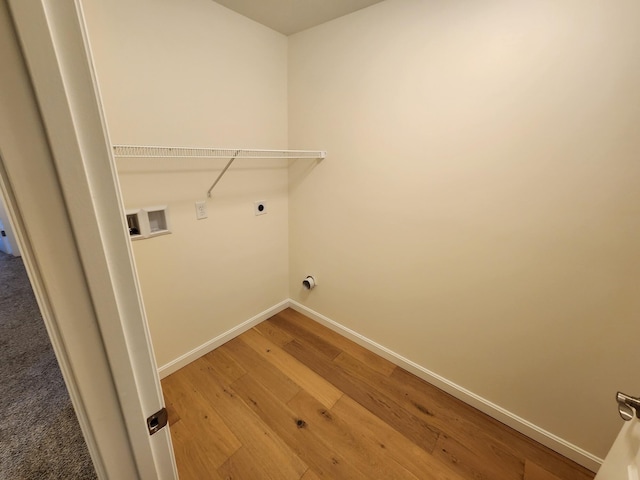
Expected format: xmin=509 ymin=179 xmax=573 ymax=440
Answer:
xmin=289 ymin=0 xmax=640 ymax=456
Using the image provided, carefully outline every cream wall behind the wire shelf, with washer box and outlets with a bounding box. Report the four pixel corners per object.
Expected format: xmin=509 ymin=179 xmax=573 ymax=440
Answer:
xmin=83 ymin=0 xmax=288 ymax=366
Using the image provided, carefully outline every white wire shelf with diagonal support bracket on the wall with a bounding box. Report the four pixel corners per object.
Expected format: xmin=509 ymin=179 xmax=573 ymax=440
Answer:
xmin=113 ymin=145 xmax=327 ymax=197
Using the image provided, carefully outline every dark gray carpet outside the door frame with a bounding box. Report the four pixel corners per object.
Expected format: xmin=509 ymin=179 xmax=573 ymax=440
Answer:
xmin=0 ymin=252 xmax=96 ymax=480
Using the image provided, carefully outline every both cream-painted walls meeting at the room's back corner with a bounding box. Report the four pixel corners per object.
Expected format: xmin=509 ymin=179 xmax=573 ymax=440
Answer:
xmin=83 ymin=0 xmax=640 ymax=462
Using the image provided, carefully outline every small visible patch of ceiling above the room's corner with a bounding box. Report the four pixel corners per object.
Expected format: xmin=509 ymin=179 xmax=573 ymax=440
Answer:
xmin=215 ymin=0 xmax=383 ymax=35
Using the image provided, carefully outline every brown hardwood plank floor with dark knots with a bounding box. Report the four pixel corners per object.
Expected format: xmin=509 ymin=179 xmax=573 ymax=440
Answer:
xmin=162 ymin=309 xmax=594 ymax=480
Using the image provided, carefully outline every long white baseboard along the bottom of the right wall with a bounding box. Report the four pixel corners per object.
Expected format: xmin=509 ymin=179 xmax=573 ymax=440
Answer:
xmin=289 ymin=300 xmax=603 ymax=472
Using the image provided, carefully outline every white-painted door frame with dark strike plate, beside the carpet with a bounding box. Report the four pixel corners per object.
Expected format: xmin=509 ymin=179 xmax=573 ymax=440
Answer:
xmin=0 ymin=0 xmax=177 ymax=479
